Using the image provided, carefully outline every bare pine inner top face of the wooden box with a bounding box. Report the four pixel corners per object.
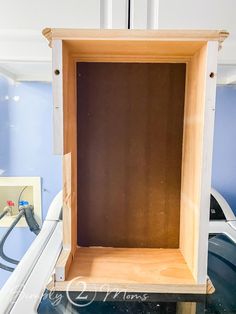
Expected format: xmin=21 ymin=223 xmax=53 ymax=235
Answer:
xmin=66 ymin=40 xmax=204 ymax=62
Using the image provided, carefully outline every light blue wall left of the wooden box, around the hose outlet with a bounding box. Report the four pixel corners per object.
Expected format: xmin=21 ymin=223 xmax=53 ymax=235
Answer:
xmin=0 ymin=76 xmax=62 ymax=287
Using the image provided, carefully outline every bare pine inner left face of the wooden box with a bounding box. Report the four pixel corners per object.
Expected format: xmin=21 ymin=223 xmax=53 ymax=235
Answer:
xmin=63 ymin=44 xmax=77 ymax=254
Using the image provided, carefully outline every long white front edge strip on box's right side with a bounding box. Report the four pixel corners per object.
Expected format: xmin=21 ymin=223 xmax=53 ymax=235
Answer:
xmin=196 ymin=41 xmax=218 ymax=283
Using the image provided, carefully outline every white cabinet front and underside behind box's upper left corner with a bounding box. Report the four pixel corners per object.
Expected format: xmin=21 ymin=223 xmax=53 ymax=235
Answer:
xmin=0 ymin=0 xmax=100 ymax=81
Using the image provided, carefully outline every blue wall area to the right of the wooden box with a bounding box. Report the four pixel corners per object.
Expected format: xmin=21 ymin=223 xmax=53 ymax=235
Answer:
xmin=212 ymin=86 xmax=236 ymax=214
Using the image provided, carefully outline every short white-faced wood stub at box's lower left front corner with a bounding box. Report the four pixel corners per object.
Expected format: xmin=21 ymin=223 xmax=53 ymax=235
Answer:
xmin=55 ymin=249 xmax=72 ymax=281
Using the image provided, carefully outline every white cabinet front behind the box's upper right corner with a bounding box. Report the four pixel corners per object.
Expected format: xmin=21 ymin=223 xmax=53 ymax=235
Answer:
xmin=159 ymin=0 xmax=236 ymax=64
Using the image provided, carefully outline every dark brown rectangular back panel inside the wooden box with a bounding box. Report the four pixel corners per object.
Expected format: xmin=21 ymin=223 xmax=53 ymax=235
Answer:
xmin=78 ymin=63 xmax=185 ymax=248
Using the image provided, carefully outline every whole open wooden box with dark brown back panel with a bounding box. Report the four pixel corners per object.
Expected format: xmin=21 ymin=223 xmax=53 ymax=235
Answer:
xmin=44 ymin=29 xmax=228 ymax=293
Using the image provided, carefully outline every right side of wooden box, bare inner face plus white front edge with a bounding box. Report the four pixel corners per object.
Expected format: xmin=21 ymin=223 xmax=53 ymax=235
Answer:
xmin=180 ymin=42 xmax=218 ymax=283
